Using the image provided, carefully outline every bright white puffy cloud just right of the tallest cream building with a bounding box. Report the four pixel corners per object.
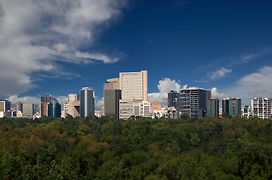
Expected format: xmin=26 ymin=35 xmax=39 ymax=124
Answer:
xmin=148 ymin=78 xmax=181 ymax=106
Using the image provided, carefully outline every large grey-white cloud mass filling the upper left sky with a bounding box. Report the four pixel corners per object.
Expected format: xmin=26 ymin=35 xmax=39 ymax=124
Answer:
xmin=0 ymin=0 xmax=126 ymax=96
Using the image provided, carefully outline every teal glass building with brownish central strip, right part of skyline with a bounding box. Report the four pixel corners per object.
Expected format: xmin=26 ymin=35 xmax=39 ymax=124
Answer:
xmin=222 ymin=97 xmax=242 ymax=117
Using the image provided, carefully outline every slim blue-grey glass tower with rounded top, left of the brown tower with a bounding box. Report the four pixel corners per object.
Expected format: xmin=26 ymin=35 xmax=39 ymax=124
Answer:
xmin=80 ymin=87 xmax=94 ymax=117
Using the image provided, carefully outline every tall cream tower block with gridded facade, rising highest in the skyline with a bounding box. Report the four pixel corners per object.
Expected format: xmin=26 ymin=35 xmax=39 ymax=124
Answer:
xmin=119 ymin=71 xmax=148 ymax=101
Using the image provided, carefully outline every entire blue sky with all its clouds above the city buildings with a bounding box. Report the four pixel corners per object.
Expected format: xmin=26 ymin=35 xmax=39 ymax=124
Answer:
xmin=0 ymin=0 xmax=272 ymax=106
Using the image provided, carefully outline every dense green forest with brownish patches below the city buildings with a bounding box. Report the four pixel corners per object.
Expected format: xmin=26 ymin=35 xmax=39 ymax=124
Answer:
xmin=0 ymin=117 xmax=272 ymax=180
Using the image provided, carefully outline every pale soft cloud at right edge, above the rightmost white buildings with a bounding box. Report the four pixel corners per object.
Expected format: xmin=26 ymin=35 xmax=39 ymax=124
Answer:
xmin=226 ymin=66 xmax=272 ymax=98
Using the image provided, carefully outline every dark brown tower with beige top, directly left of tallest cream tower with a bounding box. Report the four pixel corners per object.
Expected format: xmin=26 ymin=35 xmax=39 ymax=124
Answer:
xmin=104 ymin=78 xmax=122 ymax=119
